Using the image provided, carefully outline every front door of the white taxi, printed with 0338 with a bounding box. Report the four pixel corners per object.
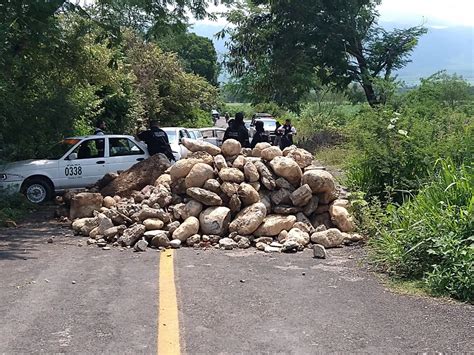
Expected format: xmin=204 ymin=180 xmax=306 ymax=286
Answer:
xmin=55 ymin=137 xmax=106 ymax=189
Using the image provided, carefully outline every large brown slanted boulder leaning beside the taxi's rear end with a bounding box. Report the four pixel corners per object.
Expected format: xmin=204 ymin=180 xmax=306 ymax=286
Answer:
xmin=100 ymin=154 xmax=171 ymax=197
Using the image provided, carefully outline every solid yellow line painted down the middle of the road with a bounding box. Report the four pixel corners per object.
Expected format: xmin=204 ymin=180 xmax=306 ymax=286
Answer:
xmin=157 ymin=249 xmax=181 ymax=355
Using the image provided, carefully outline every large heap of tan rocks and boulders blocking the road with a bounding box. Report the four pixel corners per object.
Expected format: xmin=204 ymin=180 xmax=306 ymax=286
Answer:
xmin=70 ymin=139 xmax=361 ymax=254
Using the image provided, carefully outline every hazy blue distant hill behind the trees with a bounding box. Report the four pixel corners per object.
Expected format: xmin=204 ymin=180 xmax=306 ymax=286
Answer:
xmin=192 ymin=23 xmax=474 ymax=84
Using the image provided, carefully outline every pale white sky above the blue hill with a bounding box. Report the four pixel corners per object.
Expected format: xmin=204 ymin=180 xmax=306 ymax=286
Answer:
xmin=193 ymin=0 xmax=474 ymax=28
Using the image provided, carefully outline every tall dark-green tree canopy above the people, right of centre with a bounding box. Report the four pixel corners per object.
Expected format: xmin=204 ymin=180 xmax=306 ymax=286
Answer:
xmin=221 ymin=0 xmax=426 ymax=106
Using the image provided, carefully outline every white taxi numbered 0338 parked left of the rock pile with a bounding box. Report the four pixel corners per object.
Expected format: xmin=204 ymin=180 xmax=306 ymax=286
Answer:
xmin=0 ymin=135 xmax=149 ymax=203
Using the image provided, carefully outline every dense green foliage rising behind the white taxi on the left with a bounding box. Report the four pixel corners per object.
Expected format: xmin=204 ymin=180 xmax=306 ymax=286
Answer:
xmin=0 ymin=0 xmax=218 ymax=160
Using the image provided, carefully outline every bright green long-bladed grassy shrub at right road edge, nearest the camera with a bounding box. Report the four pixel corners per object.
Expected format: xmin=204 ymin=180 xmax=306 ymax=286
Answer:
xmin=369 ymin=161 xmax=474 ymax=301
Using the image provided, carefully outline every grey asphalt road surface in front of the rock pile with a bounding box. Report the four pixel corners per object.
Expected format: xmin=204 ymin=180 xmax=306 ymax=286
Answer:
xmin=0 ymin=211 xmax=474 ymax=354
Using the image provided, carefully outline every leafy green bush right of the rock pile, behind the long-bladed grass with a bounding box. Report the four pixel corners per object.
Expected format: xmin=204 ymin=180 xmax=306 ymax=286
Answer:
xmin=347 ymin=107 xmax=474 ymax=203
